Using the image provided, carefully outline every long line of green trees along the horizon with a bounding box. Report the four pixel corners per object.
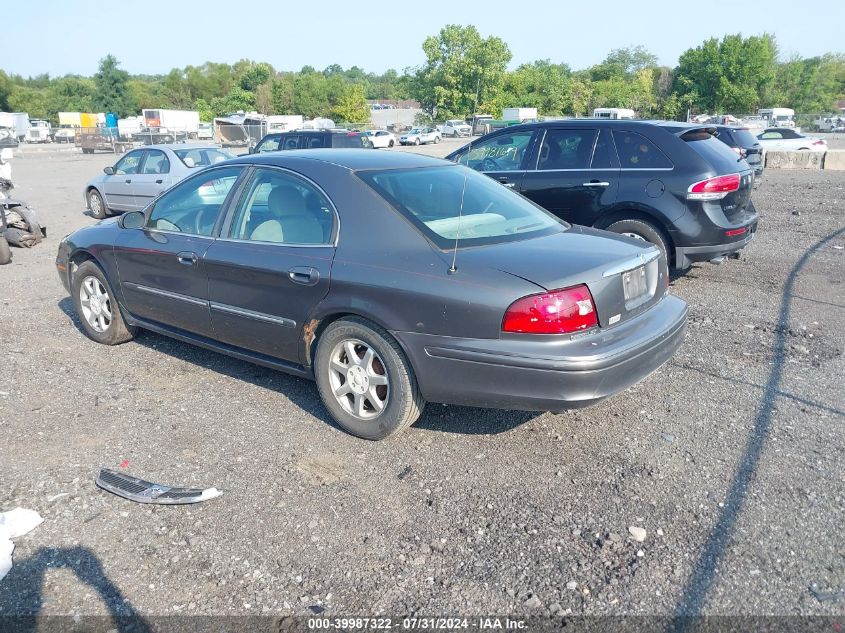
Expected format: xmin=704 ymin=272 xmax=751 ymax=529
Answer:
xmin=0 ymin=25 xmax=845 ymax=123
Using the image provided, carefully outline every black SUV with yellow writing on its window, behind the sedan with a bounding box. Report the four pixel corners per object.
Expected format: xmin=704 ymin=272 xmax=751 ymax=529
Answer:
xmin=447 ymin=119 xmax=757 ymax=269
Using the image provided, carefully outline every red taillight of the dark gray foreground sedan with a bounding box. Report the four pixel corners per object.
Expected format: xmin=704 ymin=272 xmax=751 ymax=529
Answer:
xmin=502 ymin=285 xmax=598 ymax=334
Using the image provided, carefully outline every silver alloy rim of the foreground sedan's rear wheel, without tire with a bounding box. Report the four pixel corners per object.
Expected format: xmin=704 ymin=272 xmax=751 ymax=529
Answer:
xmin=328 ymin=339 xmax=390 ymax=420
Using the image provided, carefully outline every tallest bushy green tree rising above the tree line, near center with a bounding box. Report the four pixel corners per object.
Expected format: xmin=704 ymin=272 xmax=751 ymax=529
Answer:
xmin=410 ymin=24 xmax=511 ymax=119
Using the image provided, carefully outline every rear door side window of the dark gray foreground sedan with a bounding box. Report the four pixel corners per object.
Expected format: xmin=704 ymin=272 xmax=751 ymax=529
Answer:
xmin=229 ymin=169 xmax=334 ymax=245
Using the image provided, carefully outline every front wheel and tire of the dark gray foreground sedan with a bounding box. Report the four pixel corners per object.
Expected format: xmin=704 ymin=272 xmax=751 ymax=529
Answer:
xmin=70 ymin=260 xmax=137 ymax=345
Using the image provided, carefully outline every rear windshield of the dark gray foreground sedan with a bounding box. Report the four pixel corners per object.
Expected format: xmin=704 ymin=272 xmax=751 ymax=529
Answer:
xmin=358 ymin=166 xmax=569 ymax=249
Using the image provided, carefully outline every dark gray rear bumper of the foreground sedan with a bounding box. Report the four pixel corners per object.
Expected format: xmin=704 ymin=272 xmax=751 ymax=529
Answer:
xmin=393 ymin=295 xmax=687 ymax=411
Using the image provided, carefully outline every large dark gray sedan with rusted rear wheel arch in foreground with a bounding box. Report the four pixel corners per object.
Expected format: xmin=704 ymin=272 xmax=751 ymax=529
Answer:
xmin=56 ymin=149 xmax=687 ymax=440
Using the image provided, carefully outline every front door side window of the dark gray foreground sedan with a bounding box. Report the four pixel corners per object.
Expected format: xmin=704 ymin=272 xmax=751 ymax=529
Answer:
xmin=147 ymin=166 xmax=242 ymax=235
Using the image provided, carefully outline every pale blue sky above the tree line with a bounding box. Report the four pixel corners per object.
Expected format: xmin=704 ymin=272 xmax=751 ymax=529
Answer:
xmin=13 ymin=0 xmax=845 ymax=76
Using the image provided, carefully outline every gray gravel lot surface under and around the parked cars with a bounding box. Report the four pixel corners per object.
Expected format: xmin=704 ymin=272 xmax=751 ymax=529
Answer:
xmin=0 ymin=141 xmax=845 ymax=628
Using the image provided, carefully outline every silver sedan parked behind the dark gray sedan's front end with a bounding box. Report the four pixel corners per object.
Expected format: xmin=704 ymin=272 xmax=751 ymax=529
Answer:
xmin=83 ymin=144 xmax=234 ymax=218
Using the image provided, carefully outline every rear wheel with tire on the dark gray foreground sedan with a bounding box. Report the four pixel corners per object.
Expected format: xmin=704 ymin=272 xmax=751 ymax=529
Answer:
xmin=314 ymin=317 xmax=425 ymax=440
